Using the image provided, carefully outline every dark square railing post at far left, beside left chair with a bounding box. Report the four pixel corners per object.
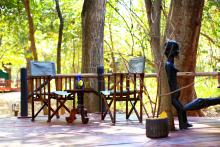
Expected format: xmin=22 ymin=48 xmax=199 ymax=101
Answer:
xmin=20 ymin=68 xmax=28 ymax=118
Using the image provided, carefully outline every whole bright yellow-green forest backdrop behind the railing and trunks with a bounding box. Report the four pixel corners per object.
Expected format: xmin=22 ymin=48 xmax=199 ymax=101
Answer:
xmin=0 ymin=0 xmax=220 ymax=129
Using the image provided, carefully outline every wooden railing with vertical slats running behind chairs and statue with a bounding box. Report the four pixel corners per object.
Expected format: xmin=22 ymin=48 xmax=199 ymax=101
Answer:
xmin=28 ymin=72 xmax=220 ymax=104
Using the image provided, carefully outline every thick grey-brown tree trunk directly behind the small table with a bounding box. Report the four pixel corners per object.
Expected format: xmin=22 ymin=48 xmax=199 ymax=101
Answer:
xmin=82 ymin=0 xmax=106 ymax=112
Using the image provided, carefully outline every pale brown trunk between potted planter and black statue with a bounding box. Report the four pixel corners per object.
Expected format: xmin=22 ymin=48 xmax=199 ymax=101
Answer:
xmin=145 ymin=0 xmax=175 ymax=130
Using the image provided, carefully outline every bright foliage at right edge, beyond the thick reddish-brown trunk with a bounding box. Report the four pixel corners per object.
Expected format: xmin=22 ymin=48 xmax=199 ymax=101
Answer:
xmin=197 ymin=0 xmax=220 ymax=71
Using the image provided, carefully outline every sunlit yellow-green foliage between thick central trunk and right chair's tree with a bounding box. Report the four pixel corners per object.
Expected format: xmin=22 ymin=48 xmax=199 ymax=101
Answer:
xmin=104 ymin=0 xmax=152 ymax=72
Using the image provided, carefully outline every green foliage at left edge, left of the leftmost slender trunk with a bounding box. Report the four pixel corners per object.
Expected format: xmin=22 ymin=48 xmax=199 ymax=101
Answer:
xmin=0 ymin=0 xmax=27 ymax=68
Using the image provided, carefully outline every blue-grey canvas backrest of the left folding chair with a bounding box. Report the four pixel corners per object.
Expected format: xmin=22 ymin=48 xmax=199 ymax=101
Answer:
xmin=30 ymin=61 xmax=56 ymax=76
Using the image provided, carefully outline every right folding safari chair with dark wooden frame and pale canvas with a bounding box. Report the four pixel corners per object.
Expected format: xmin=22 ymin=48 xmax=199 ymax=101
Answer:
xmin=101 ymin=57 xmax=145 ymax=124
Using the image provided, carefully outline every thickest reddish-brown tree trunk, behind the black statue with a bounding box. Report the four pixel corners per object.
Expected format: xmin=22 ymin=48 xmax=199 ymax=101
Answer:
xmin=166 ymin=0 xmax=204 ymax=114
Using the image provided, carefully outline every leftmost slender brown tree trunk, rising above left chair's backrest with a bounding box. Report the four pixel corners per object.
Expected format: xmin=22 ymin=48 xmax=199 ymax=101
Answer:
xmin=24 ymin=0 xmax=38 ymax=61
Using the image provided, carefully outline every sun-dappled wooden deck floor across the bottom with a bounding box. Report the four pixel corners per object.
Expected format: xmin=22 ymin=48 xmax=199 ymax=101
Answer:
xmin=0 ymin=114 xmax=220 ymax=147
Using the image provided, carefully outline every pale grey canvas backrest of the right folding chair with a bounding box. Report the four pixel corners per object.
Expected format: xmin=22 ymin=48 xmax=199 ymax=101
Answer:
xmin=128 ymin=57 xmax=145 ymax=73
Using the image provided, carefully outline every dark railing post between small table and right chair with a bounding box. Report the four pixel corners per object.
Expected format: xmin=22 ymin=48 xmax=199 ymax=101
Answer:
xmin=97 ymin=65 xmax=105 ymax=112
